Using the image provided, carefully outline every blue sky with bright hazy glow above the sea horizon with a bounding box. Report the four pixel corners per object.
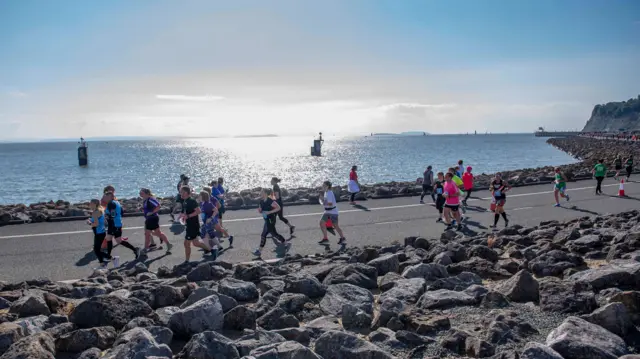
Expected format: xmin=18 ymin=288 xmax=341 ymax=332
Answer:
xmin=0 ymin=0 xmax=640 ymax=140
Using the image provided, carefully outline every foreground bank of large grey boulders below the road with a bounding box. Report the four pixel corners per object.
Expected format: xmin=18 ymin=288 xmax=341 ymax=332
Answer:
xmin=0 ymin=211 xmax=640 ymax=359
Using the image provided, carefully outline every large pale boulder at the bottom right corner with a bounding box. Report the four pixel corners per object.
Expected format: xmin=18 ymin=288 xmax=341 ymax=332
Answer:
xmin=547 ymin=317 xmax=629 ymax=359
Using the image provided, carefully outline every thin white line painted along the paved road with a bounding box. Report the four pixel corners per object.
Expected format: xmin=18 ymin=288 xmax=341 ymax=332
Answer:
xmin=0 ymin=183 xmax=632 ymax=239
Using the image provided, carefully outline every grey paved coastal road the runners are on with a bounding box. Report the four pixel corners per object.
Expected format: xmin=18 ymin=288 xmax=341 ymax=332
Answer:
xmin=0 ymin=179 xmax=640 ymax=281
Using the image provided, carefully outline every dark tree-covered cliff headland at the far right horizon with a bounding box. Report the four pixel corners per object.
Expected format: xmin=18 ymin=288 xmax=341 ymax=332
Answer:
xmin=582 ymin=96 xmax=640 ymax=132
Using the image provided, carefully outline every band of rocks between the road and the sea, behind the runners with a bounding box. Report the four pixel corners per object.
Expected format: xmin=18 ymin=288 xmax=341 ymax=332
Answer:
xmin=0 ymin=137 xmax=640 ymax=226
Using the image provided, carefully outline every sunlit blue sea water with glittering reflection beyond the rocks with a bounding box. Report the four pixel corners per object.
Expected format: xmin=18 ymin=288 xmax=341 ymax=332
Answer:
xmin=0 ymin=134 xmax=576 ymax=204
